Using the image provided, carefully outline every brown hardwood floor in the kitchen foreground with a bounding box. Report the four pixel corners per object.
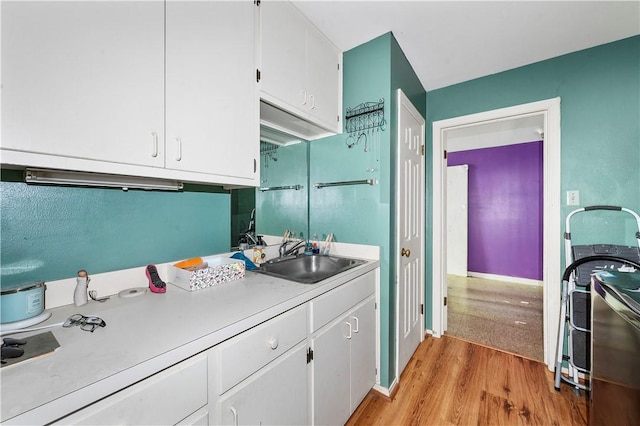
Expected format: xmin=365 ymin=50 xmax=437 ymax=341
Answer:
xmin=347 ymin=336 xmax=588 ymax=426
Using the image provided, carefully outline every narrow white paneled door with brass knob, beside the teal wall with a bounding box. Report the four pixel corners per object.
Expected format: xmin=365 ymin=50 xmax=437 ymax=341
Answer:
xmin=395 ymin=89 xmax=425 ymax=378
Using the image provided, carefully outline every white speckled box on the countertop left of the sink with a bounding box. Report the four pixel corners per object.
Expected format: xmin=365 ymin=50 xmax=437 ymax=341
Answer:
xmin=168 ymin=257 xmax=245 ymax=291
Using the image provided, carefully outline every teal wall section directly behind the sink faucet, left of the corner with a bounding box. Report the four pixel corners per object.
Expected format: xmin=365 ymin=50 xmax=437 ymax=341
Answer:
xmin=255 ymin=141 xmax=309 ymax=238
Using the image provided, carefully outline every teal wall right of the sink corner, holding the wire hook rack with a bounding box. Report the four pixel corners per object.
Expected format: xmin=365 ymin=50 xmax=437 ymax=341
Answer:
xmin=309 ymin=33 xmax=425 ymax=386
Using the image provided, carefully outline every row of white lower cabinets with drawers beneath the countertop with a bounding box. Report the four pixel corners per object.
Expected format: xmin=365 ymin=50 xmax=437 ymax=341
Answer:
xmin=47 ymin=271 xmax=376 ymax=425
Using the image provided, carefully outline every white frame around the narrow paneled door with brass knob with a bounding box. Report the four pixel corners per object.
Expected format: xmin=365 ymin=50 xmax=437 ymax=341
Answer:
xmin=390 ymin=89 xmax=426 ymax=382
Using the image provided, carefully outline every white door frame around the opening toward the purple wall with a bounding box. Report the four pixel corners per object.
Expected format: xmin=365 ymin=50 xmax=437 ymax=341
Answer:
xmin=431 ymin=97 xmax=562 ymax=370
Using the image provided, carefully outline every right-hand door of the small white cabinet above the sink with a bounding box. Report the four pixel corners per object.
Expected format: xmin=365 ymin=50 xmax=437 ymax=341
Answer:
xmin=307 ymin=25 xmax=342 ymax=133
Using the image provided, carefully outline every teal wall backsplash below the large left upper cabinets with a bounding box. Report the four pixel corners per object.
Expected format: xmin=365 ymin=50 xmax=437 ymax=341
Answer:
xmin=0 ymin=171 xmax=231 ymax=285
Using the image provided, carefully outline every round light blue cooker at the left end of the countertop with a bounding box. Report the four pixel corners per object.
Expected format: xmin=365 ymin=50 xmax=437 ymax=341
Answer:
xmin=0 ymin=282 xmax=48 ymax=328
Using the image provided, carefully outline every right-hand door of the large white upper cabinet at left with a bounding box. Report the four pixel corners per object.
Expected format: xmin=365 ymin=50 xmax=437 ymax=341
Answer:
xmin=166 ymin=0 xmax=260 ymax=182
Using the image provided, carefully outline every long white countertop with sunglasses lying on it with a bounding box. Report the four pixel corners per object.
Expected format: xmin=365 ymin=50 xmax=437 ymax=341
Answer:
xmin=0 ymin=255 xmax=379 ymax=424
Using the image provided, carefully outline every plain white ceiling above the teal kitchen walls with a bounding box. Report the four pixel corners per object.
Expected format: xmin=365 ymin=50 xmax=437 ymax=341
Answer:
xmin=292 ymin=0 xmax=640 ymax=91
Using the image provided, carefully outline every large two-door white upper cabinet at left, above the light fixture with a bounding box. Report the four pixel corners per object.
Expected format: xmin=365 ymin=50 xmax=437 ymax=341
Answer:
xmin=1 ymin=0 xmax=260 ymax=186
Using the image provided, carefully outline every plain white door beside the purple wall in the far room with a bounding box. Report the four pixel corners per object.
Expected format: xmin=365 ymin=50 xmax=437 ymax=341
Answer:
xmin=445 ymin=164 xmax=469 ymax=276
